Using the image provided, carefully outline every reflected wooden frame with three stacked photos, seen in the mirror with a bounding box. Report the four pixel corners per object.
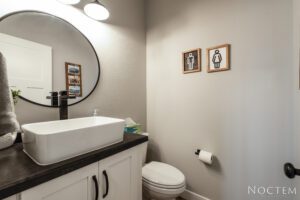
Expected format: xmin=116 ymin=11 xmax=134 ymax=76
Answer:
xmin=65 ymin=62 xmax=82 ymax=97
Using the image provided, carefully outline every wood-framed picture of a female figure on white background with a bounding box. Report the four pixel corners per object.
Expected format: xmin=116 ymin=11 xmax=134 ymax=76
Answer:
xmin=206 ymin=44 xmax=230 ymax=73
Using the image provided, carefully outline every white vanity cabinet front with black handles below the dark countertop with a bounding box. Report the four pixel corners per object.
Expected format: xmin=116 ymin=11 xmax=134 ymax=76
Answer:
xmin=20 ymin=144 xmax=144 ymax=200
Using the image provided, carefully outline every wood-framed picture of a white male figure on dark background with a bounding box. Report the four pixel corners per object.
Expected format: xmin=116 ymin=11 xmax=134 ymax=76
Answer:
xmin=182 ymin=48 xmax=201 ymax=74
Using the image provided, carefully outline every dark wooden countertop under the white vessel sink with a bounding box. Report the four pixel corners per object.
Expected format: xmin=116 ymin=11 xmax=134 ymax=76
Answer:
xmin=0 ymin=133 xmax=148 ymax=199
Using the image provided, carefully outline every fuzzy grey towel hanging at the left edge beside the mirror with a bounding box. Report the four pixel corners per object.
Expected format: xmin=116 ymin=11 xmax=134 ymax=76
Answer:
xmin=0 ymin=52 xmax=20 ymax=136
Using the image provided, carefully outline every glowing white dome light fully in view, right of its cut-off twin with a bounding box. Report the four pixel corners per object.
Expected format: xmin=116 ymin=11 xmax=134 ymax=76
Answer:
xmin=84 ymin=3 xmax=109 ymax=20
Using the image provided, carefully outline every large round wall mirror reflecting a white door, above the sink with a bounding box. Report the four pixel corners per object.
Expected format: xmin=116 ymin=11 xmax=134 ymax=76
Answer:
xmin=0 ymin=11 xmax=100 ymax=107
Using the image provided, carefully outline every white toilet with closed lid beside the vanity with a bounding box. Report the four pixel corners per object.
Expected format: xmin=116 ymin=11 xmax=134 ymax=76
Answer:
xmin=142 ymin=134 xmax=185 ymax=200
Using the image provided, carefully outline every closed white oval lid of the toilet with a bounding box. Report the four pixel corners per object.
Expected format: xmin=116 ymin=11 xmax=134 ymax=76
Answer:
xmin=142 ymin=162 xmax=185 ymax=186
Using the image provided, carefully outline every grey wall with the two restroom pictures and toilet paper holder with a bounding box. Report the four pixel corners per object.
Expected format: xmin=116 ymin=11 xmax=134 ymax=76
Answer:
xmin=146 ymin=0 xmax=293 ymax=200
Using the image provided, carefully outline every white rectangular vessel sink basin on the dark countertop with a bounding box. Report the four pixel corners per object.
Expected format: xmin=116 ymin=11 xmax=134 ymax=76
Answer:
xmin=22 ymin=117 xmax=125 ymax=165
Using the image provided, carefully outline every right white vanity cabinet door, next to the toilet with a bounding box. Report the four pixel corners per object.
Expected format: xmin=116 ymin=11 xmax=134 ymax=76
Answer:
xmin=99 ymin=147 xmax=142 ymax=200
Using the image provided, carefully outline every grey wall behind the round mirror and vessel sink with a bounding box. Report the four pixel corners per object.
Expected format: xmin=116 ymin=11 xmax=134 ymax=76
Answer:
xmin=0 ymin=0 xmax=146 ymax=126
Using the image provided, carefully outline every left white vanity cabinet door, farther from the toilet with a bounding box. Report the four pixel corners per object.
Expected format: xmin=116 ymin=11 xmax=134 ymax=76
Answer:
xmin=21 ymin=163 xmax=98 ymax=200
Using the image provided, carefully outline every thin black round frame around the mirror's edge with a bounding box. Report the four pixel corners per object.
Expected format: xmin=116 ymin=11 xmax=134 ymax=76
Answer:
xmin=0 ymin=10 xmax=101 ymax=108
